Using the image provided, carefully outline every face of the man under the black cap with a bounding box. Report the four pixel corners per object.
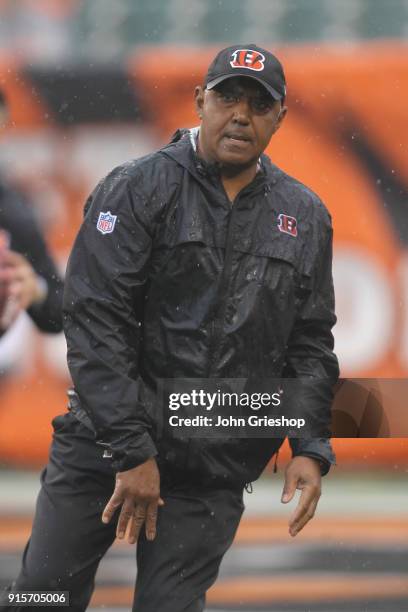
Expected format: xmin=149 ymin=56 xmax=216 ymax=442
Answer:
xmin=195 ymin=77 xmax=286 ymax=168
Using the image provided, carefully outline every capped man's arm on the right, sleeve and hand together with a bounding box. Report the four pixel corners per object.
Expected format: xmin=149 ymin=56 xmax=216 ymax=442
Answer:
xmin=282 ymin=209 xmax=339 ymax=535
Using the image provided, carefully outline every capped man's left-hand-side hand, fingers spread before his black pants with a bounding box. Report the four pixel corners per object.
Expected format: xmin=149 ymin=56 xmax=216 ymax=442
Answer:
xmin=102 ymin=459 xmax=164 ymax=544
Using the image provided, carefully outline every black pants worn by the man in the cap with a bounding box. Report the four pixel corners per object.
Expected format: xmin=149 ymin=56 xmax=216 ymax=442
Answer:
xmin=0 ymin=414 xmax=243 ymax=612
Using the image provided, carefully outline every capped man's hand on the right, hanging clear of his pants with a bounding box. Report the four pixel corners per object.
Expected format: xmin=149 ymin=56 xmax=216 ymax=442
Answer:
xmin=282 ymin=457 xmax=322 ymax=537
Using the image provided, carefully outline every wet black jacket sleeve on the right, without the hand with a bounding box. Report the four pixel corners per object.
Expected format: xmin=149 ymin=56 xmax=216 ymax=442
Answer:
xmin=285 ymin=218 xmax=339 ymax=475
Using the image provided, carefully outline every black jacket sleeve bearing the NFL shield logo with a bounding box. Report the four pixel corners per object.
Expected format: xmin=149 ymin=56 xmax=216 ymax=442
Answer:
xmin=64 ymin=170 xmax=157 ymax=471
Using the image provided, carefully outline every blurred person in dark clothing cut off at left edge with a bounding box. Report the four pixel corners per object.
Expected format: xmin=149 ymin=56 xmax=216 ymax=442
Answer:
xmin=0 ymin=91 xmax=63 ymax=336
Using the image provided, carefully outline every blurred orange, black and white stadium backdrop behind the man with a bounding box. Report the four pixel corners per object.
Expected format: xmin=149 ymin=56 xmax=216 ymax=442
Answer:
xmin=0 ymin=0 xmax=408 ymax=612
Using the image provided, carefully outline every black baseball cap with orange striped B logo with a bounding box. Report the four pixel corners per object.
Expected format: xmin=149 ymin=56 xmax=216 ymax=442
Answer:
xmin=204 ymin=44 xmax=286 ymax=100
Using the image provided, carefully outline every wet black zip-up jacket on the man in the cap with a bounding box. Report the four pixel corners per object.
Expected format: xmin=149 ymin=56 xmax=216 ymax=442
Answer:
xmin=64 ymin=130 xmax=338 ymax=482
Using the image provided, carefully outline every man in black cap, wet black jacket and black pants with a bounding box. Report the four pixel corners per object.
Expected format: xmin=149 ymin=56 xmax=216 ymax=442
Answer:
xmin=3 ymin=45 xmax=338 ymax=612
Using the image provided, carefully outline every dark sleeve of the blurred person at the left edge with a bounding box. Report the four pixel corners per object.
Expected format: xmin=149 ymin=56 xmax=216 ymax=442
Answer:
xmin=0 ymin=178 xmax=63 ymax=335
